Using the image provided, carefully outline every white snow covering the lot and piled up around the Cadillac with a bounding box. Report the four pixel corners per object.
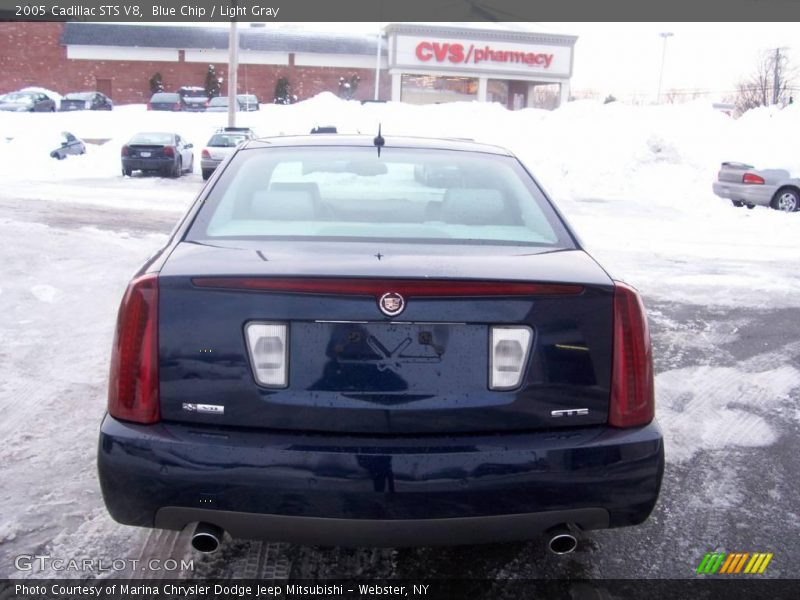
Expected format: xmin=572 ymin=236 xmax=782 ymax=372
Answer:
xmin=0 ymin=94 xmax=800 ymax=576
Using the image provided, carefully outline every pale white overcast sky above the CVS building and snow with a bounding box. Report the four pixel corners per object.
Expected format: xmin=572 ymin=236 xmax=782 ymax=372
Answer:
xmin=147 ymin=21 xmax=800 ymax=101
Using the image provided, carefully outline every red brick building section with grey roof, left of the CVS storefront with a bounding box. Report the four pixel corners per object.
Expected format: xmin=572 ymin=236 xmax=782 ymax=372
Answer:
xmin=0 ymin=22 xmax=391 ymax=104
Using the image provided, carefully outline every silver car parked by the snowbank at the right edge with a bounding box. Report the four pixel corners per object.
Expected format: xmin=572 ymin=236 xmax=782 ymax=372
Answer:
xmin=712 ymin=162 xmax=800 ymax=212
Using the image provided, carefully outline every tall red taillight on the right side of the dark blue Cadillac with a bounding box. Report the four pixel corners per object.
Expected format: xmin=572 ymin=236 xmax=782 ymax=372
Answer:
xmin=608 ymin=281 xmax=655 ymax=427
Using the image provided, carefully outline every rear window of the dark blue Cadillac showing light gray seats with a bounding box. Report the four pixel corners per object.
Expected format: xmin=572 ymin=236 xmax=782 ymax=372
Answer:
xmin=187 ymin=147 xmax=573 ymax=247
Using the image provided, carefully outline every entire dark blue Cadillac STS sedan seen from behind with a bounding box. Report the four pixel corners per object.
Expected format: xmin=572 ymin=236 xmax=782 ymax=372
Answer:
xmin=98 ymin=136 xmax=664 ymax=551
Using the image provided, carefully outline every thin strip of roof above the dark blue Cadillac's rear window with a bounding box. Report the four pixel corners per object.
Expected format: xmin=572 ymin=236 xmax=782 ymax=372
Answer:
xmin=242 ymin=133 xmax=512 ymax=156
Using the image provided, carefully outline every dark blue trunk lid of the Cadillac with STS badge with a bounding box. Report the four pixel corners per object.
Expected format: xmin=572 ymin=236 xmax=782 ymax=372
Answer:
xmin=159 ymin=242 xmax=613 ymax=434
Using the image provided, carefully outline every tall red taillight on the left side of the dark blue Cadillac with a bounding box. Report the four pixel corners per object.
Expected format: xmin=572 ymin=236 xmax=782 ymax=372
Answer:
xmin=108 ymin=274 xmax=161 ymax=423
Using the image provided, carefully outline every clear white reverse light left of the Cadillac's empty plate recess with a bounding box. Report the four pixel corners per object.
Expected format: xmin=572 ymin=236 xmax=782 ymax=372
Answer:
xmin=245 ymin=322 xmax=289 ymax=388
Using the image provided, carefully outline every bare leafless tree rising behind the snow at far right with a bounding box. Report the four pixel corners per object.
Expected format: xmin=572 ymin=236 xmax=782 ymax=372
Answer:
xmin=734 ymin=48 xmax=795 ymax=114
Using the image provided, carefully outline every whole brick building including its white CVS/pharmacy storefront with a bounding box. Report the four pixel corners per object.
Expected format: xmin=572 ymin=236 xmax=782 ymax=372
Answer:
xmin=0 ymin=22 xmax=577 ymax=109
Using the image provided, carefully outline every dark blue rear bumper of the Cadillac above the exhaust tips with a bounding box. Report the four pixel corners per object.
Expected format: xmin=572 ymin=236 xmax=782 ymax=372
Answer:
xmin=98 ymin=416 xmax=664 ymax=546
